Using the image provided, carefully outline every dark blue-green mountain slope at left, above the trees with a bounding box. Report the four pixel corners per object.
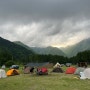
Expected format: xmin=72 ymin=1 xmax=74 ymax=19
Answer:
xmin=0 ymin=37 xmax=34 ymax=59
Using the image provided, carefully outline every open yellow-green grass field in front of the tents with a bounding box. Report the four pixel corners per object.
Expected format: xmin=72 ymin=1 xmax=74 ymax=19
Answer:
xmin=0 ymin=67 xmax=90 ymax=90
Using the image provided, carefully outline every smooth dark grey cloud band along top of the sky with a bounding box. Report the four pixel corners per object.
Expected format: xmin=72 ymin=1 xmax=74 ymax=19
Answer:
xmin=0 ymin=0 xmax=90 ymax=21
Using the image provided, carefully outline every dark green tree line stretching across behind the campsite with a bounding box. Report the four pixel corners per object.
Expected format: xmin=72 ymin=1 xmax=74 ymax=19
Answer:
xmin=0 ymin=49 xmax=90 ymax=66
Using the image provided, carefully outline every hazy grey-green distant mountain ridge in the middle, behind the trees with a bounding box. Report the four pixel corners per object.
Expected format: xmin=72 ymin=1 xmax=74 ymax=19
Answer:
xmin=14 ymin=41 xmax=66 ymax=56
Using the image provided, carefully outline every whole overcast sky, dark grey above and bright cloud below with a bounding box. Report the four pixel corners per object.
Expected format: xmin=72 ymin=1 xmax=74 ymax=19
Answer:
xmin=0 ymin=0 xmax=90 ymax=47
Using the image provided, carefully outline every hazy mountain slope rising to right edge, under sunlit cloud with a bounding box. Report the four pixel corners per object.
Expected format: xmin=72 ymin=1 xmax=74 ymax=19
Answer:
xmin=61 ymin=38 xmax=90 ymax=57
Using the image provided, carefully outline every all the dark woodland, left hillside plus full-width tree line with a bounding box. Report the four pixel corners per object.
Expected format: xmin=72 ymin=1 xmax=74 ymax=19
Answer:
xmin=0 ymin=38 xmax=90 ymax=65
